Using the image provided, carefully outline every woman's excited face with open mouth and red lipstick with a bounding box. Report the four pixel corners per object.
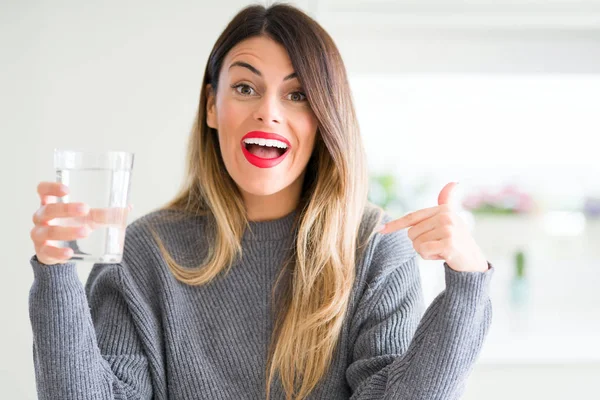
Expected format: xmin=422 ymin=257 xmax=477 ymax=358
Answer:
xmin=207 ymin=37 xmax=317 ymax=214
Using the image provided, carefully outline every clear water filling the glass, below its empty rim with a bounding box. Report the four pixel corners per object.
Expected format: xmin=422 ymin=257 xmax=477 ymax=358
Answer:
xmin=52 ymin=169 xmax=131 ymax=263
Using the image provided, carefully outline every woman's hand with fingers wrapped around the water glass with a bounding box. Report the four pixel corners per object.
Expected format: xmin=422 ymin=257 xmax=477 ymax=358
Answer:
xmin=30 ymin=182 xmax=92 ymax=265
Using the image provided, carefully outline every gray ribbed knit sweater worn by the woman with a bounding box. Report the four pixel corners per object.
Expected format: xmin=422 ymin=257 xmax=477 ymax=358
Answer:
xmin=29 ymin=205 xmax=494 ymax=400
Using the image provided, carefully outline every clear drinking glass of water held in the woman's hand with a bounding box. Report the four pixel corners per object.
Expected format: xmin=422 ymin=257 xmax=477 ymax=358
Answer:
xmin=53 ymin=149 xmax=134 ymax=263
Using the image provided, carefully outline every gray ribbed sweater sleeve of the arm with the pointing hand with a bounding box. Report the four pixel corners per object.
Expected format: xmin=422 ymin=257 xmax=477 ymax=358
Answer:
xmin=346 ymin=233 xmax=494 ymax=400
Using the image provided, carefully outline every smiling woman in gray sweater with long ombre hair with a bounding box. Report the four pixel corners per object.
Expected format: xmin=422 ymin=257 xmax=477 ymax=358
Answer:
xmin=30 ymin=5 xmax=493 ymax=399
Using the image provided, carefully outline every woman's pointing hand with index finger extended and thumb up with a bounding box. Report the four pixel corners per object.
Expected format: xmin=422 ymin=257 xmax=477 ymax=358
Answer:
xmin=379 ymin=182 xmax=488 ymax=272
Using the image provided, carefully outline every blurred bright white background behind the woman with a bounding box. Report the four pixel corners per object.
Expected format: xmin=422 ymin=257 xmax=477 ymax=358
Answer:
xmin=0 ymin=0 xmax=600 ymax=400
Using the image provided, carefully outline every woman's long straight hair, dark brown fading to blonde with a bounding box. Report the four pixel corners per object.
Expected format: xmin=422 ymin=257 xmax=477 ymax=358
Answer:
xmin=144 ymin=4 xmax=382 ymax=399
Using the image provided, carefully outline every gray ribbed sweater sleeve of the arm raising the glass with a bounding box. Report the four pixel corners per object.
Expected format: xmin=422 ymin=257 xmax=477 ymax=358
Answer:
xmin=29 ymin=256 xmax=153 ymax=400
